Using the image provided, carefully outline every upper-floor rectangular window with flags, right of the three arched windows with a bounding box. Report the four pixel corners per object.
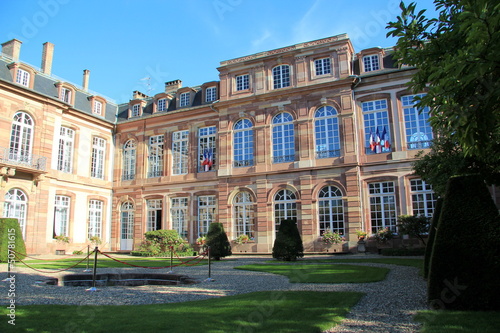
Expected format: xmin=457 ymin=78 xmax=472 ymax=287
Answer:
xmin=361 ymin=99 xmax=391 ymax=154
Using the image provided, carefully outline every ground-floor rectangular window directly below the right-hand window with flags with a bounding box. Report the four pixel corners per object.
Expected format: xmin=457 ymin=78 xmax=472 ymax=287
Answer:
xmin=368 ymin=182 xmax=397 ymax=233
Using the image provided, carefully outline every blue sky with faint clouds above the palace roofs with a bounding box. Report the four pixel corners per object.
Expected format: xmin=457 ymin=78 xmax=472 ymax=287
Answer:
xmin=0 ymin=0 xmax=434 ymax=103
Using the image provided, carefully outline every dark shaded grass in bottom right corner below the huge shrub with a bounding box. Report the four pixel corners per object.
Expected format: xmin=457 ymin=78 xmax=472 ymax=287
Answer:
xmin=415 ymin=311 xmax=500 ymax=333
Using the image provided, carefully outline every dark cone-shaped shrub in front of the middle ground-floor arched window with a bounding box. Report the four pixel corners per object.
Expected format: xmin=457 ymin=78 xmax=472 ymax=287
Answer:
xmin=273 ymin=219 xmax=304 ymax=261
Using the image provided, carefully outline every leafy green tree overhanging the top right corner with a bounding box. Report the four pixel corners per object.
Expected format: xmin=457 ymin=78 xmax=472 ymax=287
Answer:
xmin=387 ymin=0 xmax=500 ymax=164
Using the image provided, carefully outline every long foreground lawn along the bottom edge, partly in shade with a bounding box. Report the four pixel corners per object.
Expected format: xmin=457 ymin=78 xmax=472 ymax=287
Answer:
xmin=0 ymin=291 xmax=363 ymax=333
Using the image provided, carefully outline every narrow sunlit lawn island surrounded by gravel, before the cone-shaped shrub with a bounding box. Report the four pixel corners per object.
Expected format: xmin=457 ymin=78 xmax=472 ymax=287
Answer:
xmin=235 ymin=264 xmax=389 ymax=283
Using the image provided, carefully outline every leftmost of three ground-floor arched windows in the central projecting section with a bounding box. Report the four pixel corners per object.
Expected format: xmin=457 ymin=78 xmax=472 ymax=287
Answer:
xmin=233 ymin=192 xmax=255 ymax=238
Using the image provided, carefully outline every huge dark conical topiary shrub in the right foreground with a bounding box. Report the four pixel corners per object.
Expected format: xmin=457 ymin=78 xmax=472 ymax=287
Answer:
xmin=428 ymin=176 xmax=500 ymax=311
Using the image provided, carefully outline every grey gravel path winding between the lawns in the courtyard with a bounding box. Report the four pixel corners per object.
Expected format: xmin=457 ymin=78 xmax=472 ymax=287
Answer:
xmin=0 ymin=255 xmax=426 ymax=333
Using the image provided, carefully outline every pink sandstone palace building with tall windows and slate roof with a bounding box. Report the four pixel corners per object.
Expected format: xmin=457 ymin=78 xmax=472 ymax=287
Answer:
xmin=0 ymin=34 xmax=480 ymax=254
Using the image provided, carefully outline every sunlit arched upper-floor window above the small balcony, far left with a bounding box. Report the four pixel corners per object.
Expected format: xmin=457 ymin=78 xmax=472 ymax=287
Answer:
xmin=9 ymin=112 xmax=34 ymax=164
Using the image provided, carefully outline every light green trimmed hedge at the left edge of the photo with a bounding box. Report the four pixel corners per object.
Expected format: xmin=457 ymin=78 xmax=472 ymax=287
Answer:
xmin=0 ymin=218 xmax=26 ymax=262
